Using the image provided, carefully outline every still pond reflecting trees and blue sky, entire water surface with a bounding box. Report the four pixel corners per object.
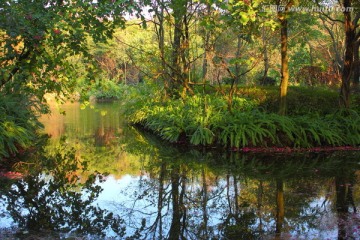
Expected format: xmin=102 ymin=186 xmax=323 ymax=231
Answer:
xmin=0 ymin=102 xmax=360 ymax=239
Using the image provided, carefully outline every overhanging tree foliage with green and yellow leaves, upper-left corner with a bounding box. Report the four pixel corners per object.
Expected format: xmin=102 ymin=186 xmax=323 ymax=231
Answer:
xmin=0 ymin=1 xmax=134 ymax=98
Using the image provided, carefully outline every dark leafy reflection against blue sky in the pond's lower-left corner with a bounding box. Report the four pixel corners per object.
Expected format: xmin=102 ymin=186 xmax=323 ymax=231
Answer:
xmin=2 ymin=142 xmax=125 ymax=236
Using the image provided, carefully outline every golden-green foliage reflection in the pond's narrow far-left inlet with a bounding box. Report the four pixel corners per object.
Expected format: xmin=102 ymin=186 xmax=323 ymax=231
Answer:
xmin=45 ymin=102 xmax=140 ymax=178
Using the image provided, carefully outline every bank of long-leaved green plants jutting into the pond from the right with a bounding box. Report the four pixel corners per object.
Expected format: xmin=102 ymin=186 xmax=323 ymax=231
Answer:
xmin=126 ymin=85 xmax=360 ymax=149
